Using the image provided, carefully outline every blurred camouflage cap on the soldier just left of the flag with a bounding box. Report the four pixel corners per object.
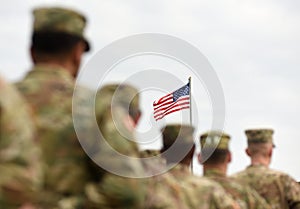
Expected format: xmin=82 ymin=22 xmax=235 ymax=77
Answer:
xmin=96 ymin=84 xmax=141 ymax=125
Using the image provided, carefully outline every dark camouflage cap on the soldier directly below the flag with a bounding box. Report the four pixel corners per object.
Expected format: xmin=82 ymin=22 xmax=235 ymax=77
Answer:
xmin=161 ymin=124 xmax=194 ymax=148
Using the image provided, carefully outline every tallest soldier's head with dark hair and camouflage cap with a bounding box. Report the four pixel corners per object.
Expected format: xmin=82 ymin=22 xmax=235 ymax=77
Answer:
xmin=31 ymin=7 xmax=90 ymax=77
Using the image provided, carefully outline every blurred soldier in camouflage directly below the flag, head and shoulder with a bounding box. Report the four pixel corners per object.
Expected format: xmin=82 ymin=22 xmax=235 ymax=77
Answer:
xmin=161 ymin=124 xmax=239 ymax=208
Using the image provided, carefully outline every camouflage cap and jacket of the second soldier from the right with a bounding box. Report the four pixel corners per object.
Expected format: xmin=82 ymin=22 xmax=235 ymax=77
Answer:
xmin=200 ymin=131 xmax=270 ymax=209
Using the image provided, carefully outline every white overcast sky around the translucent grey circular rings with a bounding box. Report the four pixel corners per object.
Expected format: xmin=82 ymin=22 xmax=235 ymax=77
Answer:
xmin=0 ymin=0 xmax=300 ymax=181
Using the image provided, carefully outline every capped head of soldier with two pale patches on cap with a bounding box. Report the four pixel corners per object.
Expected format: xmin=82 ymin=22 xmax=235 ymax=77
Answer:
xmin=198 ymin=130 xmax=231 ymax=169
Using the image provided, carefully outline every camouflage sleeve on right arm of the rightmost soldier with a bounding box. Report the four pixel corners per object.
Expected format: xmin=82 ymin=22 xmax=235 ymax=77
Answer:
xmin=281 ymin=175 xmax=300 ymax=209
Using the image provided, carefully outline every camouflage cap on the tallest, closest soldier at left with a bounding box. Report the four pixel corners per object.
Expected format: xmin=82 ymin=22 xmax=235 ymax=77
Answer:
xmin=33 ymin=7 xmax=90 ymax=51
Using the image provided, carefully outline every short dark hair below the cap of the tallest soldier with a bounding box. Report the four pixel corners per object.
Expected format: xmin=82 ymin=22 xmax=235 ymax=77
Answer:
xmin=31 ymin=32 xmax=82 ymax=55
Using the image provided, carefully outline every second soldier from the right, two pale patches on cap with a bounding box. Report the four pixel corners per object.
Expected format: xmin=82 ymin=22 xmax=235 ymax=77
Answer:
xmin=199 ymin=131 xmax=270 ymax=209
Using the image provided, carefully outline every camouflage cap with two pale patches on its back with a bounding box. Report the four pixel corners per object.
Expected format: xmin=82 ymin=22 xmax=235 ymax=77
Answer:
xmin=200 ymin=130 xmax=230 ymax=150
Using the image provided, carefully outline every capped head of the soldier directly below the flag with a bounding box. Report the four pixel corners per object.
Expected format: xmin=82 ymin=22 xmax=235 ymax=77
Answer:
xmin=161 ymin=124 xmax=195 ymax=165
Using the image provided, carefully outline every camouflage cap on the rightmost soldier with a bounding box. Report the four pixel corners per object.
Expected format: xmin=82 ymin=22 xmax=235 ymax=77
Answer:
xmin=245 ymin=129 xmax=275 ymax=146
